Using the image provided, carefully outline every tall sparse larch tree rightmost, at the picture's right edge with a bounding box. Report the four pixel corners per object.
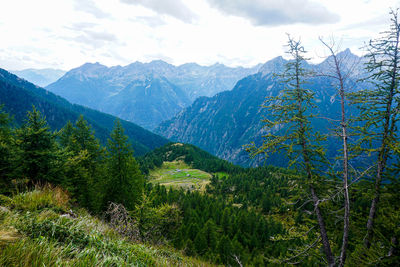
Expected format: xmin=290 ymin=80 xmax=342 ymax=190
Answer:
xmin=352 ymin=10 xmax=400 ymax=248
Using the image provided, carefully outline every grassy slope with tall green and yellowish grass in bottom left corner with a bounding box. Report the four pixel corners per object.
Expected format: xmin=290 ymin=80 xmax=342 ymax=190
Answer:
xmin=0 ymin=186 xmax=217 ymax=267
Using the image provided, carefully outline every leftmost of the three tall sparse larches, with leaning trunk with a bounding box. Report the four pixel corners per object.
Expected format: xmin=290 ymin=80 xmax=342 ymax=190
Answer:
xmin=250 ymin=36 xmax=335 ymax=266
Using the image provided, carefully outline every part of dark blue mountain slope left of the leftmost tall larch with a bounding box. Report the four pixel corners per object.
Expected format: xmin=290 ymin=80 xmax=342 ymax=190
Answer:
xmin=155 ymin=73 xmax=272 ymax=163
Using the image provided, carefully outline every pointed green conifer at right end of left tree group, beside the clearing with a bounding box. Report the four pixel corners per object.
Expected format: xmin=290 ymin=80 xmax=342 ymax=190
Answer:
xmin=106 ymin=120 xmax=144 ymax=210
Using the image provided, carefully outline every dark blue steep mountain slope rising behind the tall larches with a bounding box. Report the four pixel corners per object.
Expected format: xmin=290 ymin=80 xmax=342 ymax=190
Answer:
xmin=155 ymin=50 xmax=366 ymax=165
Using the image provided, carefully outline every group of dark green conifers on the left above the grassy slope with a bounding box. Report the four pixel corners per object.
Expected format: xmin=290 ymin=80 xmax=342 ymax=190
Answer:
xmin=0 ymin=107 xmax=148 ymax=216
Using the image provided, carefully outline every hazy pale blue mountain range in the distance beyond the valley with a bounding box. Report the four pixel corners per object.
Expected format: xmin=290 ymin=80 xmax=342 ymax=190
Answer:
xmin=46 ymin=60 xmax=259 ymax=132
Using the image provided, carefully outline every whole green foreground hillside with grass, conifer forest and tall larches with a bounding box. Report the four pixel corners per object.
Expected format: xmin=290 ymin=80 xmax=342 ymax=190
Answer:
xmin=0 ymin=10 xmax=400 ymax=267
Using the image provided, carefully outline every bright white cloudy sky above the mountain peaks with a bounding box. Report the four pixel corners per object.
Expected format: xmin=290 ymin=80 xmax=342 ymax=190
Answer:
xmin=0 ymin=0 xmax=400 ymax=70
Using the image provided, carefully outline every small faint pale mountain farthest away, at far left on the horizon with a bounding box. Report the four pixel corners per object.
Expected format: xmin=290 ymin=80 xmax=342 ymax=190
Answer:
xmin=11 ymin=69 xmax=65 ymax=87
